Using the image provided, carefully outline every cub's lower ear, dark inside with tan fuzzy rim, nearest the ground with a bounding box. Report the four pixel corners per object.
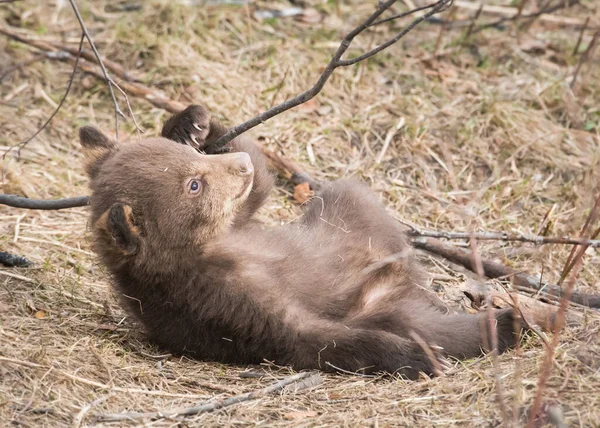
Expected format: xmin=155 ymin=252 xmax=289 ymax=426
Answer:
xmin=96 ymin=203 xmax=141 ymax=256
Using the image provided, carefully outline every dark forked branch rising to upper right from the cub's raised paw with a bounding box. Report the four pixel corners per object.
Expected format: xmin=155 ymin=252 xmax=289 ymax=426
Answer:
xmin=213 ymin=0 xmax=453 ymax=148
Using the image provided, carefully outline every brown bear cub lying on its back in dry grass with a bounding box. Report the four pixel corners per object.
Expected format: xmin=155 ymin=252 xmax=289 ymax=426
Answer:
xmin=81 ymin=106 xmax=515 ymax=378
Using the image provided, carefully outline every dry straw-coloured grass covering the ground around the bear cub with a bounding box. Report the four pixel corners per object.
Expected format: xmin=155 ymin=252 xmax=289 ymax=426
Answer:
xmin=0 ymin=0 xmax=600 ymax=426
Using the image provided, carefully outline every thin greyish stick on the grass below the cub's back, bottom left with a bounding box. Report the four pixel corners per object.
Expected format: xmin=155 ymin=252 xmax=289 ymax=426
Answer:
xmin=98 ymin=372 xmax=319 ymax=422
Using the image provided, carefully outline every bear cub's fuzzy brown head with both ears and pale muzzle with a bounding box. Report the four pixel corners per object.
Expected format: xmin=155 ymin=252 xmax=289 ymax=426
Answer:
xmin=79 ymin=127 xmax=254 ymax=265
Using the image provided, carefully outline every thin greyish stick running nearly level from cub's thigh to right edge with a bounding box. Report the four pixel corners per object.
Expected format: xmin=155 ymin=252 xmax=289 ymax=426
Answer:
xmin=408 ymin=229 xmax=600 ymax=248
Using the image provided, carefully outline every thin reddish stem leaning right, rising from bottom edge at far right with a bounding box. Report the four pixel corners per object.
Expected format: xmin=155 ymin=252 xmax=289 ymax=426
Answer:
xmin=527 ymin=194 xmax=600 ymax=428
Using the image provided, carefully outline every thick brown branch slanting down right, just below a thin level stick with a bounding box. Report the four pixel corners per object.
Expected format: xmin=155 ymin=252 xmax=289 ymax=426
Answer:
xmin=412 ymin=237 xmax=600 ymax=308
